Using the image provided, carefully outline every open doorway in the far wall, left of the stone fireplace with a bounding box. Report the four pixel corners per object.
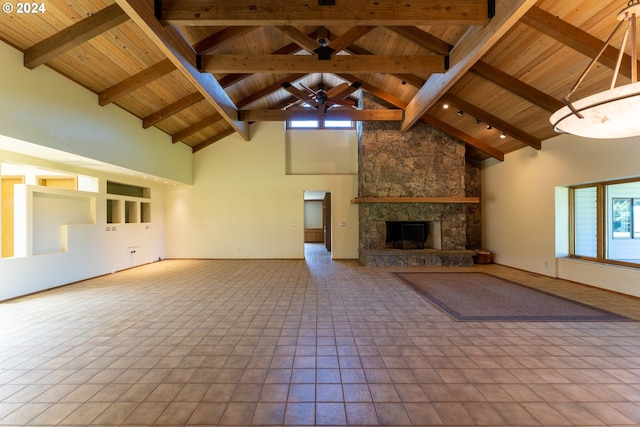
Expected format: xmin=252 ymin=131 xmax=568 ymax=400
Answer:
xmin=304 ymin=190 xmax=332 ymax=257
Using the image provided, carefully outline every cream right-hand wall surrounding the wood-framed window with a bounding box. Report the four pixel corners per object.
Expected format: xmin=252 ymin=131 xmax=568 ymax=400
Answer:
xmin=481 ymin=135 xmax=640 ymax=296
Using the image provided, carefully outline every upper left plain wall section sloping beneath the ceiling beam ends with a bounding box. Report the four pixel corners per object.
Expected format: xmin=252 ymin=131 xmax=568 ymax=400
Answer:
xmin=0 ymin=41 xmax=192 ymax=183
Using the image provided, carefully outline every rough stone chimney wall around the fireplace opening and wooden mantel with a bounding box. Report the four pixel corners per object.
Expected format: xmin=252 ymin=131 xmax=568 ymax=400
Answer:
xmin=358 ymin=96 xmax=480 ymax=264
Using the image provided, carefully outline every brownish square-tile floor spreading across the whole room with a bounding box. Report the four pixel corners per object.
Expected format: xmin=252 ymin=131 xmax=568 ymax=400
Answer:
xmin=0 ymin=246 xmax=640 ymax=426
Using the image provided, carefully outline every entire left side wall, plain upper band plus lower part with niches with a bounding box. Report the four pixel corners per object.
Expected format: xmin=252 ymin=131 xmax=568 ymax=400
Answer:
xmin=0 ymin=42 xmax=181 ymax=300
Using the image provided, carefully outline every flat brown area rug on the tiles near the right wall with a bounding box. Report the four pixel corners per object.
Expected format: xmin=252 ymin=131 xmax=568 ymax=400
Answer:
xmin=393 ymin=272 xmax=631 ymax=322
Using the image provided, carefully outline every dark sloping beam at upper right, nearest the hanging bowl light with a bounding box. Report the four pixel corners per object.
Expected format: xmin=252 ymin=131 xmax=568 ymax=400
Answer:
xmin=522 ymin=7 xmax=640 ymax=77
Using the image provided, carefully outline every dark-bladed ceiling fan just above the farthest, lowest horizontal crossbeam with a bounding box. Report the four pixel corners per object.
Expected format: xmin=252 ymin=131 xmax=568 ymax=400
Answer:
xmin=282 ymin=82 xmax=361 ymax=113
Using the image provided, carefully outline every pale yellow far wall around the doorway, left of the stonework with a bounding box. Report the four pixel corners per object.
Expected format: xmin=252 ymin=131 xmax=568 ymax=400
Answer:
xmin=166 ymin=122 xmax=358 ymax=259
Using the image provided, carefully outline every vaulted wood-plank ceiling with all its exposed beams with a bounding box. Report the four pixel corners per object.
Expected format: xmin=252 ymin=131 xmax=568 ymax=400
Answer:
xmin=0 ymin=0 xmax=630 ymax=160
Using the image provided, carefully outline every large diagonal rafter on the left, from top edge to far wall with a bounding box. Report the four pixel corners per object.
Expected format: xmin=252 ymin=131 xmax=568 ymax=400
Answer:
xmin=116 ymin=0 xmax=250 ymax=141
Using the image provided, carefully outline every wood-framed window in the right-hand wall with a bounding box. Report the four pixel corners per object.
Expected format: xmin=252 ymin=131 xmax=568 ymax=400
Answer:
xmin=570 ymin=180 xmax=640 ymax=267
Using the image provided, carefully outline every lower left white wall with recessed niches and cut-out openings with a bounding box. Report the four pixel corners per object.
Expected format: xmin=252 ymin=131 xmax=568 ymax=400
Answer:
xmin=0 ymin=151 xmax=165 ymax=301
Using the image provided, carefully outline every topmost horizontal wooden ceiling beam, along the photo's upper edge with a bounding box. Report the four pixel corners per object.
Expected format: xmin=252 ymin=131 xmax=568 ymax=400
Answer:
xmin=160 ymin=0 xmax=489 ymax=26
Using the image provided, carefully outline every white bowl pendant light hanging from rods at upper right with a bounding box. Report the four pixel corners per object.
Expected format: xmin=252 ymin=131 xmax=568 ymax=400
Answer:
xmin=549 ymin=0 xmax=640 ymax=138
